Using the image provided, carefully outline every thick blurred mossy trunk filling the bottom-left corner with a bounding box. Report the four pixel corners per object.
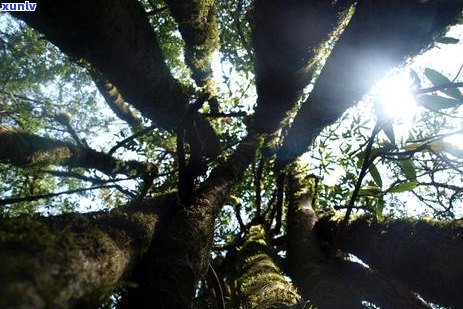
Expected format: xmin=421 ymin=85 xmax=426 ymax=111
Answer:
xmin=0 ymin=195 xmax=173 ymax=308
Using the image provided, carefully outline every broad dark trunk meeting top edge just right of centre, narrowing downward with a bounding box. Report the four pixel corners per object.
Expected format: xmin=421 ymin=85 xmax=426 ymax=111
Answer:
xmin=252 ymin=0 xmax=348 ymax=133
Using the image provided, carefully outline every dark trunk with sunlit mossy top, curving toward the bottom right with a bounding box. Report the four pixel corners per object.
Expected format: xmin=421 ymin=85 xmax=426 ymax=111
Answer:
xmin=287 ymin=168 xmax=428 ymax=309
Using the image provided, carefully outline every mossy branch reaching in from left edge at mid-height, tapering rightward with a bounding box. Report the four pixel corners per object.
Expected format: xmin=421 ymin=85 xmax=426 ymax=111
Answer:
xmin=0 ymin=126 xmax=157 ymax=176
